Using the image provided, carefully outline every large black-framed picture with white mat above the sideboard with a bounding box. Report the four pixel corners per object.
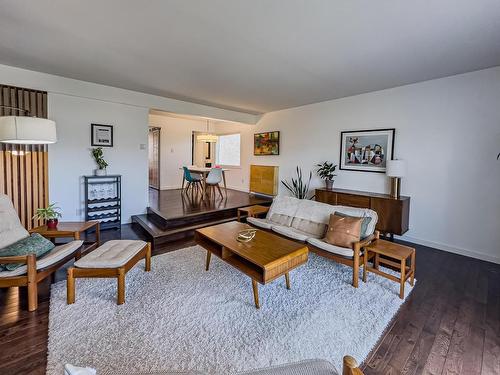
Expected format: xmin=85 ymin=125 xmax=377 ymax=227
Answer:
xmin=340 ymin=129 xmax=395 ymax=173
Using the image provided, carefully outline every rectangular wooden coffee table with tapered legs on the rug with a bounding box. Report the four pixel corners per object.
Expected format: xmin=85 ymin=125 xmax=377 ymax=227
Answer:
xmin=195 ymin=221 xmax=309 ymax=308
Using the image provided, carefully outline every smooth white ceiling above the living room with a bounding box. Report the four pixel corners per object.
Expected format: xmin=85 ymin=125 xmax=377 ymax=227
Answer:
xmin=0 ymin=0 xmax=500 ymax=113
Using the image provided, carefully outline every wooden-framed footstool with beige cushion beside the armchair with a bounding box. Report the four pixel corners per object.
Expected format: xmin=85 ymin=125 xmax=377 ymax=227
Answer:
xmin=67 ymin=240 xmax=151 ymax=305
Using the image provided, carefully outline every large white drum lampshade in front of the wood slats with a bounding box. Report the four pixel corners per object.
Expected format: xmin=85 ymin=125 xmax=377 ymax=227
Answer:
xmin=0 ymin=105 xmax=57 ymax=145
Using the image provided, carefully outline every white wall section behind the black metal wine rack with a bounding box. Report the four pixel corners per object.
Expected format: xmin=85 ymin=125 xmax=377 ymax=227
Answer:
xmin=48 ymin=94 xmax=148 ymax=222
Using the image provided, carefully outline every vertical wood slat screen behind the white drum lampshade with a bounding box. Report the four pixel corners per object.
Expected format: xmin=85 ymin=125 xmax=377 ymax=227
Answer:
xmin=0 ymin=85 xmax=49 ymax=229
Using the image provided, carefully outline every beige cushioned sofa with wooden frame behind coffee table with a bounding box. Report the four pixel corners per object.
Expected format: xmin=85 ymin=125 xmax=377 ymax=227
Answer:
xmin=247 ymin=196 xmax=379 ymax=287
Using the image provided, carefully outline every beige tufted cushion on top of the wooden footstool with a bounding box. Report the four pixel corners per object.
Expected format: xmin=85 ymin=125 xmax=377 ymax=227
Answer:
xmin=75 ymin=240 xmax=146 ymax=268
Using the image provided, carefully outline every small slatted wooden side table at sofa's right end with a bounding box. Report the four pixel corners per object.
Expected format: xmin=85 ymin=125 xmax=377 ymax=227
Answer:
xmin=363 ymin=239 xmax=415 ymax=299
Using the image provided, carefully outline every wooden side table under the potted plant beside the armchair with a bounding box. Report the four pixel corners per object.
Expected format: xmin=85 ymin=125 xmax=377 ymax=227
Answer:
xmin=29 ymin=221 xmax=100 ymax=252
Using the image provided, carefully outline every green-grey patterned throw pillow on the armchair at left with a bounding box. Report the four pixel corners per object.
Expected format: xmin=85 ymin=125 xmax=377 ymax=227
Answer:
xmin=0 ymin=233 xmax=55 ymax=271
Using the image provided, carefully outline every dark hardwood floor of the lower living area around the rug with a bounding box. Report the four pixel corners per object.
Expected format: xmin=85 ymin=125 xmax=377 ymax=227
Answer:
xmin=0 ymin=225 xmax=500 ymax=375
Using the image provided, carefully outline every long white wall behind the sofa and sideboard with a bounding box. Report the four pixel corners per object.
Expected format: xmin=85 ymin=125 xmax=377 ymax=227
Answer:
xmin=219 ymin=67 xmax=500 ymax=263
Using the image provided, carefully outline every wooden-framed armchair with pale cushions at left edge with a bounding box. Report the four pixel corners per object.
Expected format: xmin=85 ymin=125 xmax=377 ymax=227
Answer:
xmin=0 ymin=194 xmax=83 ymax=311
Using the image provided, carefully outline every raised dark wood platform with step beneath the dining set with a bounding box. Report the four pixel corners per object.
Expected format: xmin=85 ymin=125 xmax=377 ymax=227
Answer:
xmin=132 ymin=189 xmax=272 ymax=248
